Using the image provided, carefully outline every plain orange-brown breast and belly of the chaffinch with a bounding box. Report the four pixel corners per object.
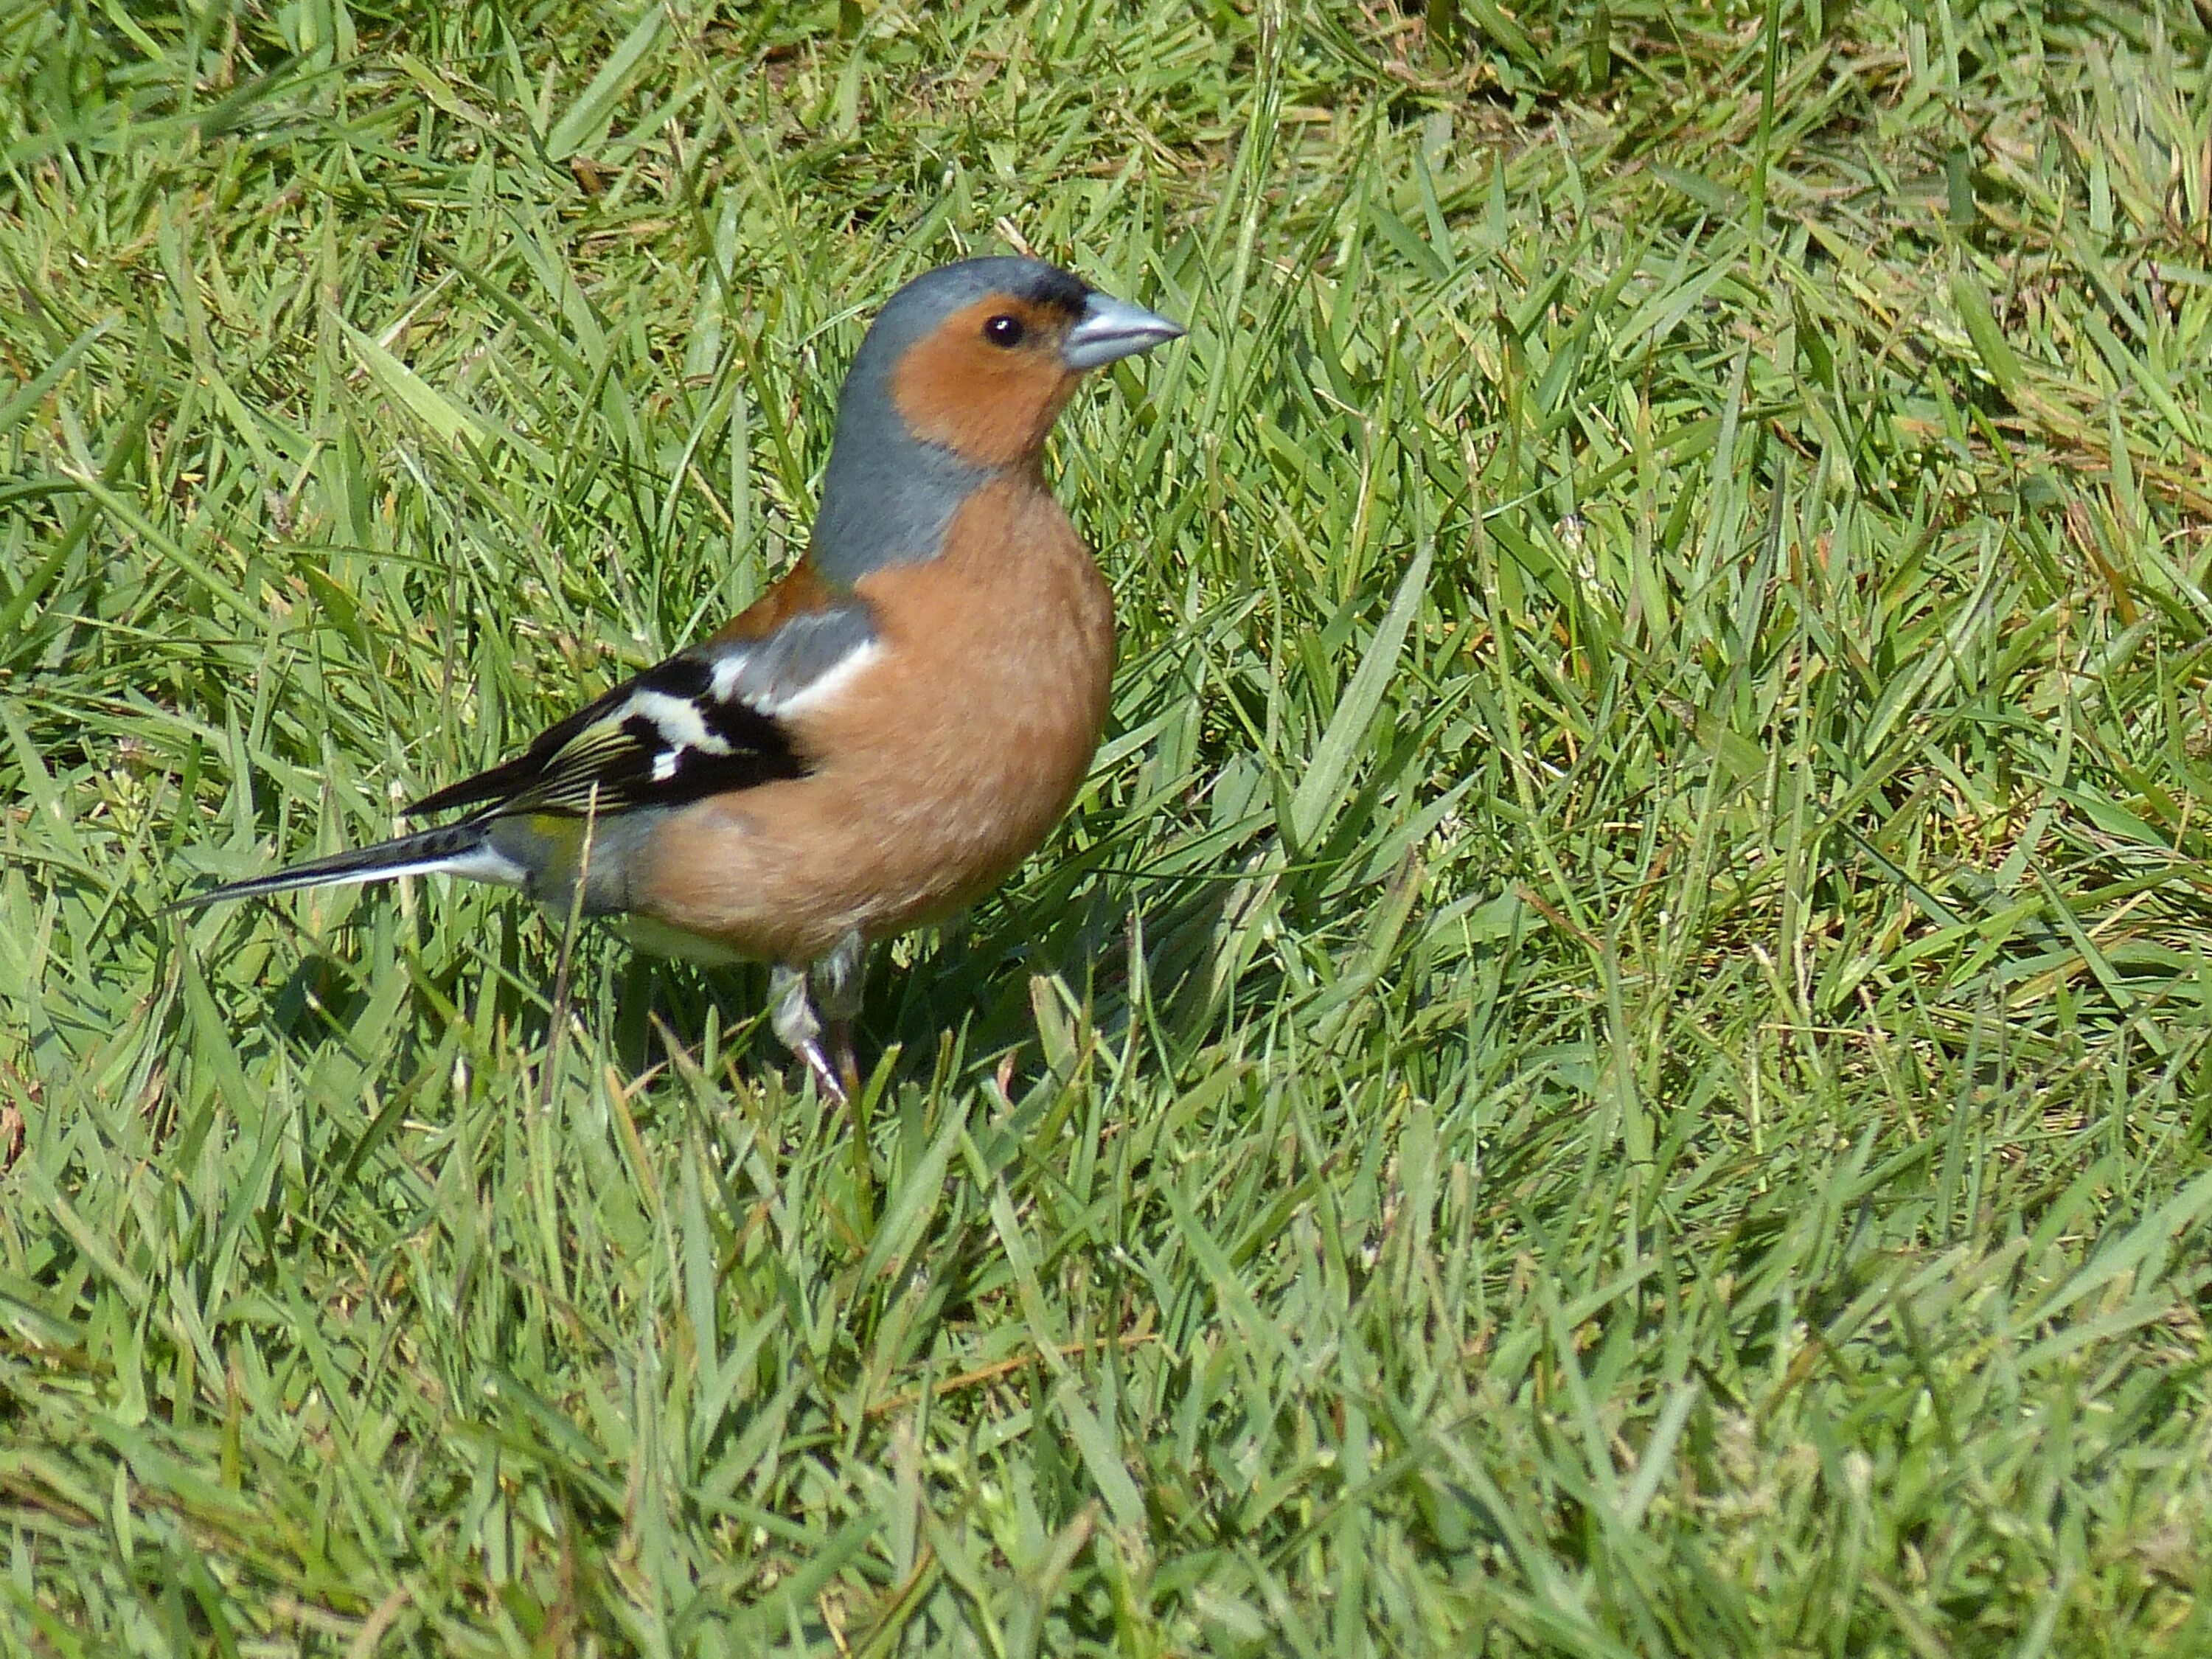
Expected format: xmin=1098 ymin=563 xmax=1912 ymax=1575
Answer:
xmin=633 ymin=480 xmax=1113 ymax=964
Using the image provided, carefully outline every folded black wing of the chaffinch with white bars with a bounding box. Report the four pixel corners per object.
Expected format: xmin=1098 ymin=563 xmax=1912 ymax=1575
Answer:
xmin=407 ymin=580 xmax=876 ymax=818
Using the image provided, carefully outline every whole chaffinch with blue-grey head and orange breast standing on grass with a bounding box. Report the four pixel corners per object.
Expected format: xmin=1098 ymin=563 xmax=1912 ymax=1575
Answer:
xmin=173 ymin=254 xmax=1183 ymax=1104
